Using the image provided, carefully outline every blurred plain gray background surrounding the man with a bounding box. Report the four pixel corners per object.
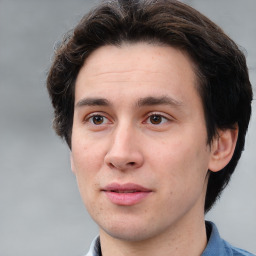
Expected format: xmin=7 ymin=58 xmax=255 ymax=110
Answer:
xmin=0 ymin=0 xmax=256 ymax=256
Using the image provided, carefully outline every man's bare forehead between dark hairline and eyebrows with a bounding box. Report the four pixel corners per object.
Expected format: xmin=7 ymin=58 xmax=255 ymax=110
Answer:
xmin=75 ymin=43 xmax=198 ymax=106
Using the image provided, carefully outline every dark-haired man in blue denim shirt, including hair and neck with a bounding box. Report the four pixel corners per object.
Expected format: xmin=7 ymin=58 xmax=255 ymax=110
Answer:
xmin=47 ymin=0 xmax=252 ymax=256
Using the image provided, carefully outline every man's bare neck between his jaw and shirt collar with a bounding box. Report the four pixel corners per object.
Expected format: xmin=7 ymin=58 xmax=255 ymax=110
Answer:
xmin=100 ymin=213 xmax=207 ymax=256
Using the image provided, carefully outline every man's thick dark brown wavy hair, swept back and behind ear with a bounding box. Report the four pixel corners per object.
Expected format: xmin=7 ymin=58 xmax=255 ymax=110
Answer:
xmin=47 ymin=0 xmax=252 ymax=212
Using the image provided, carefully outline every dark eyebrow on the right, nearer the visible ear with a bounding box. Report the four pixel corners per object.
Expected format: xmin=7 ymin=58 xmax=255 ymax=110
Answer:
xmin=137 ymin=96 xmax=183 ymax=107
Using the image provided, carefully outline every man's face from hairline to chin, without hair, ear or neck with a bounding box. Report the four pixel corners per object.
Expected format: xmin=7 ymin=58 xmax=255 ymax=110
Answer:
xmin=71 ymin=43 xmax=215 ymax=241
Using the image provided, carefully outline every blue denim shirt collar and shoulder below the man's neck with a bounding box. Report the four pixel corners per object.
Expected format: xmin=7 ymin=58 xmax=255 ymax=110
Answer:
xmin=86 ymin=221 xmax=255 ymax=256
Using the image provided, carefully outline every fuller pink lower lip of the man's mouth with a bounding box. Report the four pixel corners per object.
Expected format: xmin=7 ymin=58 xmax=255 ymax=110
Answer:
xmin=104 ymin=191 xmax=151 ymax=206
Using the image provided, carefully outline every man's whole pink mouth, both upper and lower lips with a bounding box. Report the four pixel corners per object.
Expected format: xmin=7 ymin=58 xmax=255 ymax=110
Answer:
xmin=102 ymin=183 xmax=152 ymax=206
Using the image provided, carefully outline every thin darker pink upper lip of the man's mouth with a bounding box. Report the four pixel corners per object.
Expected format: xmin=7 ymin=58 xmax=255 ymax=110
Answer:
xmin=102 ymin=183 xmax=152 ymax=192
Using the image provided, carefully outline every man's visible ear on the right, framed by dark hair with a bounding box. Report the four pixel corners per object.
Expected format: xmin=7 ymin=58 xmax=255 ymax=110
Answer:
xmin=208 ymin=125 xmax=238 ymax=172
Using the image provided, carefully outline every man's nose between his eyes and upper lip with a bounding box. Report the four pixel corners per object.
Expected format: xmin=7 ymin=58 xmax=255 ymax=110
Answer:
xmin=105 ymin=125 xmax=144 ymax=171
